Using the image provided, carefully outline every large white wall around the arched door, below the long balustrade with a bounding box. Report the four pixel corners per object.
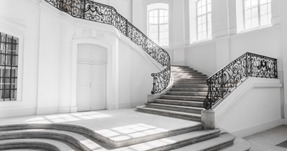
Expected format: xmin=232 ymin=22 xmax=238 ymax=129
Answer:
xmin=0 ymin=0 xmax=160 ymax=118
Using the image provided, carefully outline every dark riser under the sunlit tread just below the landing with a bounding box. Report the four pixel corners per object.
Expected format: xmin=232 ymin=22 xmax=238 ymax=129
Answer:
xmin=153 ymin=133 xmax=219 ymax=151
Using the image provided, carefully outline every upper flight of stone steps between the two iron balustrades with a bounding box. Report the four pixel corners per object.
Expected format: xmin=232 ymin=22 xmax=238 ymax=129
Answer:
xmin=137 ymin=66 xmax=208 ymax=122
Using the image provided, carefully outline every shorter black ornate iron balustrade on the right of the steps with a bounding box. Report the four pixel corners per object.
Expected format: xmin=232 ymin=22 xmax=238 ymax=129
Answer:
xmin=203 ymin=52 xmax=278 ymax=110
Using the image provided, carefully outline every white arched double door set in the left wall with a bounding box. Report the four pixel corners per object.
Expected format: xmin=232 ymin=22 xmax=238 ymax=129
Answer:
xmin=77 ymin=45 xmax=106 ymax=111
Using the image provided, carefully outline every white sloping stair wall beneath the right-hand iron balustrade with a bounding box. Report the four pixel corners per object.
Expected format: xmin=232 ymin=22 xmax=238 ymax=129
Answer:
xmin=214 ymin=78 xmax=284 ymax=137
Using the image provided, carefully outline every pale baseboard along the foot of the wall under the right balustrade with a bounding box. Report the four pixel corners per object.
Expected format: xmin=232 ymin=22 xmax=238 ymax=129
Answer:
xmin=232 ymin=119 xmax=286 ymax=137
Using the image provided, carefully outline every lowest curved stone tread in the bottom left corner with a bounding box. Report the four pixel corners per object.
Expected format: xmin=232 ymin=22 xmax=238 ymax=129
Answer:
xmin=0 ymin=139 xmax=76 ymax=151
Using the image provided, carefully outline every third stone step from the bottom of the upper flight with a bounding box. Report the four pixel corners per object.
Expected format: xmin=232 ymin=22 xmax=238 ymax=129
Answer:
xmin=155 ymin=99 xmax=203 ymax=108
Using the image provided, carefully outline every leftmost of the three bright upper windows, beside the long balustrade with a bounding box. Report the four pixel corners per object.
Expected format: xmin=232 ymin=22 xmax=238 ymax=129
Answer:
xmin=147 ymin=3 xmax=169 ymax=46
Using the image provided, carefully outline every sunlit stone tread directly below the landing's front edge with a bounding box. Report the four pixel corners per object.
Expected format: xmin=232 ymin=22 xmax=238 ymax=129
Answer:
xmin=115 ymin=129 xmax=220 ymax=151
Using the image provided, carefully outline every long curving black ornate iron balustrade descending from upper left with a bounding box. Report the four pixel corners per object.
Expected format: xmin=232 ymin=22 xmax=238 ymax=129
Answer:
xmin=45 ymin=0 xmax=171 ymax=94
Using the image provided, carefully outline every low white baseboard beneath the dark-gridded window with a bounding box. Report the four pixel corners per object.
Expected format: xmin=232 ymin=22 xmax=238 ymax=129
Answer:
xmin=0 ymin=108 xmax=36 ymax=118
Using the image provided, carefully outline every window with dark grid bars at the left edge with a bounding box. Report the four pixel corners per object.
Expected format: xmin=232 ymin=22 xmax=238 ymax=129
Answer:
xmin=0 ymin=32 xmax=19 ymax=101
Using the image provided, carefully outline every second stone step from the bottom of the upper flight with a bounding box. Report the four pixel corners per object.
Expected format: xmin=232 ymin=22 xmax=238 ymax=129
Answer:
xmin=146 ymin=103 xmax=203 ymax=114
